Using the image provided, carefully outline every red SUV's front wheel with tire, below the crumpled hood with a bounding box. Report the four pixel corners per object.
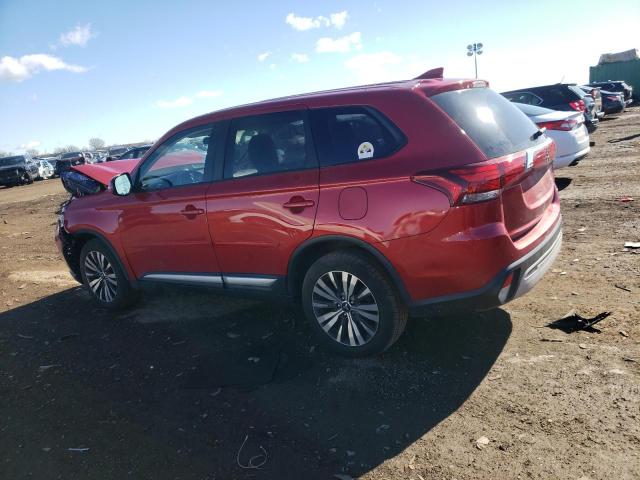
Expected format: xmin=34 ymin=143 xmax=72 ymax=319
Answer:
xmin=80 ymin=239 xmax=138 ymax=310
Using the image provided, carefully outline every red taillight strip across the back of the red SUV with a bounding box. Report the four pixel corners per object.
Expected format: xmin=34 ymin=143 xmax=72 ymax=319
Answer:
xmin=411 ymin=140 xmax=556 ymax=206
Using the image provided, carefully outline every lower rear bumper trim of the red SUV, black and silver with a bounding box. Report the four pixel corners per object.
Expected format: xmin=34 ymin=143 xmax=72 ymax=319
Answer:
xmin=409 ymin=219 xmax=562 ymax=317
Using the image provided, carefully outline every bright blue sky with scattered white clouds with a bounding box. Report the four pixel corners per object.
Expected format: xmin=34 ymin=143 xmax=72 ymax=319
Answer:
xmin=0 ymin=0 xmax=640 ymax=153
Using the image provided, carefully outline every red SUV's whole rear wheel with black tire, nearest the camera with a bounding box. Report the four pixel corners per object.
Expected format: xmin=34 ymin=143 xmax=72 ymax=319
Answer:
xmin=301 ymin=250 xmax=407 ymax=357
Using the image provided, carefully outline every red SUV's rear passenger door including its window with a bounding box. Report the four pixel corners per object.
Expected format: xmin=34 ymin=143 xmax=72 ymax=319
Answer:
xmin=207 ymin=109 xmax=318 ymax=287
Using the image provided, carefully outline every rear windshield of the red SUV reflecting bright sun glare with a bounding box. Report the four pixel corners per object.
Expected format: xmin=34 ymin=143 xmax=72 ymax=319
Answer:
xmin=431 ymin=88 xmax=544 ymax=158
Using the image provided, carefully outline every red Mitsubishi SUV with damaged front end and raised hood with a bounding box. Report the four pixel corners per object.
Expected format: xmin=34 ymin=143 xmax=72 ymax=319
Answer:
xmin=57 ymin=78 xmax=562 ymax=355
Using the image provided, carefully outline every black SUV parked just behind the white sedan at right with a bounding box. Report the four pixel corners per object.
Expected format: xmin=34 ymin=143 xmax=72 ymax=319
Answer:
xmin=502 ymin=83 xmax=599 ymax=133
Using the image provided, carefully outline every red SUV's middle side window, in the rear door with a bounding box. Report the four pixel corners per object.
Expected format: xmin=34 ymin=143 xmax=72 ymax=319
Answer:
xmin=224 ymin=111 xmax=311 ymax=178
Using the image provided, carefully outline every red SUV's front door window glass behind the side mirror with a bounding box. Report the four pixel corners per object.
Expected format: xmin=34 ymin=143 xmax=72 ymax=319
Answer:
xmin=139 ymin=125 xmax=212 ymax=192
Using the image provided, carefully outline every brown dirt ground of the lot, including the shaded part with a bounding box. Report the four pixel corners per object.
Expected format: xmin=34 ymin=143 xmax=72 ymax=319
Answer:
xmin=0 ymin=107 xmax=640 ymax=480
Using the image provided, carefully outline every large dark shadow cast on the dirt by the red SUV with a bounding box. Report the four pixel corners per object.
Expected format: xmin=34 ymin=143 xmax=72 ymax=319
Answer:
xmin=0 ymin=289 xmax=511 ymax=479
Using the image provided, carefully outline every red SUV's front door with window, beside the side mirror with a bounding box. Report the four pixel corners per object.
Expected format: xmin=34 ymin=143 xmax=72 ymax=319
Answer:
xmin=120 ymin=125 xmax=220 ymax=283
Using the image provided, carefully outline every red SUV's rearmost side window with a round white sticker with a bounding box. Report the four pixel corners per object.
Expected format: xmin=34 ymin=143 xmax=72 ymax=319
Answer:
xmin=311 ymin=107 xmax=405 ymax=167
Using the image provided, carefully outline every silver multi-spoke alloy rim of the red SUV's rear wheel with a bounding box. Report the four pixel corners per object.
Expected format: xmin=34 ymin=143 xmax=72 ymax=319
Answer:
xmin=312 ymin=271 xmax=380 ymax=347
